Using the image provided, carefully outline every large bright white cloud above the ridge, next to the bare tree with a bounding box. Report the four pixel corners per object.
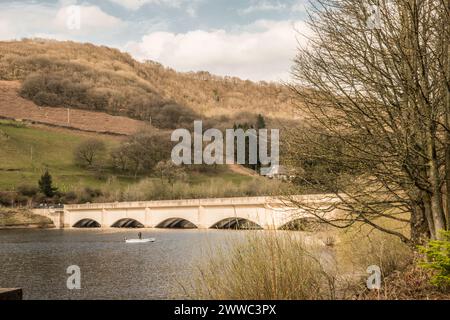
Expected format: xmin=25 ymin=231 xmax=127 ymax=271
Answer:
xmin=125 ymin=20 xmax=307 ymax=81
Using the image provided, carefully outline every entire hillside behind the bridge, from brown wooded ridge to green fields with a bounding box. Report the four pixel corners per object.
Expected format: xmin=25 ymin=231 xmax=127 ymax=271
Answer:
xmin=0 ymin=40 xmax=296 ymax=203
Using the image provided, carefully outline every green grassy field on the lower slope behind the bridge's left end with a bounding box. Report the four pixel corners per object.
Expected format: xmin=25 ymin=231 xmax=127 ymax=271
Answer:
xmin=0 ymin=120 xmax=251 ymax=191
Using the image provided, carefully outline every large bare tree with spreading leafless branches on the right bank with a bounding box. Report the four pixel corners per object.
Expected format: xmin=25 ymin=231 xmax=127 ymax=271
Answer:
xmin=290 ymin=0 xmax=450 ymax=243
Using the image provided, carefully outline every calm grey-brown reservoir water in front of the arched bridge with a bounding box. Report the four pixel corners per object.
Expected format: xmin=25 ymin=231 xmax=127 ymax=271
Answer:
xmin=0 ymin=229 xmax=243 ymax=299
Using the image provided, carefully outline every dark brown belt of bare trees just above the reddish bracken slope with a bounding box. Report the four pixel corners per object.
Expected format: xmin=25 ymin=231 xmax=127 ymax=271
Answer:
xmin=20 ymin=71 xmax=200 ymax=129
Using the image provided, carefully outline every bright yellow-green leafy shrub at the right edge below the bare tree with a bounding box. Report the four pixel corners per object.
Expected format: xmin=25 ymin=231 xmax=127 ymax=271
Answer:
xmin=419 ymin=231 xmax=450 ymax=289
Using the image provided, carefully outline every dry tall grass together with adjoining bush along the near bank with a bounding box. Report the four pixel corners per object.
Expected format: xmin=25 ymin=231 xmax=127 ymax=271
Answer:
xmin=183 ymin=220 xmax=413 ymax=300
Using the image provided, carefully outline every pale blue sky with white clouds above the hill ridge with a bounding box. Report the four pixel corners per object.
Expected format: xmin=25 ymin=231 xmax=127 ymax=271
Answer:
xmin=0 ymin=0 xmax=308 ymax=81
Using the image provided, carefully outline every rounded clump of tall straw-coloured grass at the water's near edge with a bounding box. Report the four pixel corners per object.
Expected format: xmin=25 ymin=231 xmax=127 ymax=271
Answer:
xmin=184 ymin=232 xmax=335 ymax=300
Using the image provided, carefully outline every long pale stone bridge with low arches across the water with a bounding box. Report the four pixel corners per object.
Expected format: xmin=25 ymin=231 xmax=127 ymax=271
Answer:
xmin=35 ymin=195 xmax=335 ymax=229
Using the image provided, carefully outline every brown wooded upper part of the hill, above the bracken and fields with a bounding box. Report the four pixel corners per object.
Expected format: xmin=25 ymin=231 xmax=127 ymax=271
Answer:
xmin=0 ymin=40 xmax=295 ymax=129
